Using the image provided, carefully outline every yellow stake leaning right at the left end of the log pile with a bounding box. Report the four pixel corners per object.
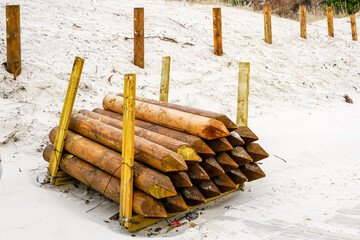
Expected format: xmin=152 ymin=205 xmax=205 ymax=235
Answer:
xmin=48 ymin=57 xmax=85 ymax=185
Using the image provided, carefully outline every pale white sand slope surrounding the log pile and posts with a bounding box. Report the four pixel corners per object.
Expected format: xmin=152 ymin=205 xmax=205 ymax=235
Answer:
xmin=0 ymin=0 xmax=360 ymax=239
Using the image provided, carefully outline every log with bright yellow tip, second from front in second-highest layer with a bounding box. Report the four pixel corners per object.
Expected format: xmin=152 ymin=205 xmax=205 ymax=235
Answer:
xmin=79 ymin=110 xmax=201 ymax=162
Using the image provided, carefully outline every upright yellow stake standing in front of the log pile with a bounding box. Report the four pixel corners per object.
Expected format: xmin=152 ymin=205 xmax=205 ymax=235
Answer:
xmin=120 ymin=74 xmax=136 ymax=228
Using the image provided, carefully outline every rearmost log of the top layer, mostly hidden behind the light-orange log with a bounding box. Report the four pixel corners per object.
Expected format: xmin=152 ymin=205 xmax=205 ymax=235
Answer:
xmin=117 ymin=94 xmax=238 ymax=131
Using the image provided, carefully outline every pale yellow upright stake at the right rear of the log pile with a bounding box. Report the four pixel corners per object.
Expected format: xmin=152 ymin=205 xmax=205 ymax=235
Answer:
xmin=236 ymin=62 xmax=250 ymax=188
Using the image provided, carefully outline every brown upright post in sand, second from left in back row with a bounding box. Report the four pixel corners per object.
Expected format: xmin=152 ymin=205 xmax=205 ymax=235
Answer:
xmin=134 ymin=8 xmax=145 ymax=68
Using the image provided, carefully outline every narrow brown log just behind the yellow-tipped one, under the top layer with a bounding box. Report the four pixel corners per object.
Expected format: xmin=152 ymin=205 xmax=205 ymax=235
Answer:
xmin=93 ymin=108 xmax=215 ymax=157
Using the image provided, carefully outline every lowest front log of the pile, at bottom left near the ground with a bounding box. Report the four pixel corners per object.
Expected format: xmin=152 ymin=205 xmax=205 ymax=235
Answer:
xmin=43 ymin=146 xmax=167 ymax=217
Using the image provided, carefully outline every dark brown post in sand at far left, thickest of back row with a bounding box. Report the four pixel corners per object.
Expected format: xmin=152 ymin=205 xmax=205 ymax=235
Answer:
xmin=6 ymin=5 xmax=21 ymax=78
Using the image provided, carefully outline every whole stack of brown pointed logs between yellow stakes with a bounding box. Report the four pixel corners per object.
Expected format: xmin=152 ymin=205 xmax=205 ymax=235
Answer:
xmin=43 ymin=94 xmax=268 ymax=221
